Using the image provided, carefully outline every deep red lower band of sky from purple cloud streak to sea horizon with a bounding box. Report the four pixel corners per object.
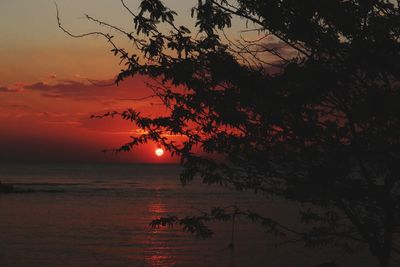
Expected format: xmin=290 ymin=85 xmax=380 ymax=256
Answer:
xmin=0 ymin=75 xmax=180 ymax=163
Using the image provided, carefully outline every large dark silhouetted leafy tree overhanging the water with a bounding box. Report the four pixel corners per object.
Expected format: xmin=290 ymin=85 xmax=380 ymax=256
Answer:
xmin=60 ymin=0 xmax=400 ymax=267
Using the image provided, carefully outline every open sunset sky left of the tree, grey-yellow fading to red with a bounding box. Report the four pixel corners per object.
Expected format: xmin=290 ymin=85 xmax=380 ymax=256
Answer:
xmin=0 ymin=0 xmax=197 ymax=163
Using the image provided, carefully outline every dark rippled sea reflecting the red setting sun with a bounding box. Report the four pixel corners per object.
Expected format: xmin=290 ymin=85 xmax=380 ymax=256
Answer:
xmin=0 ymin=164 xmax=376 ymax=267
